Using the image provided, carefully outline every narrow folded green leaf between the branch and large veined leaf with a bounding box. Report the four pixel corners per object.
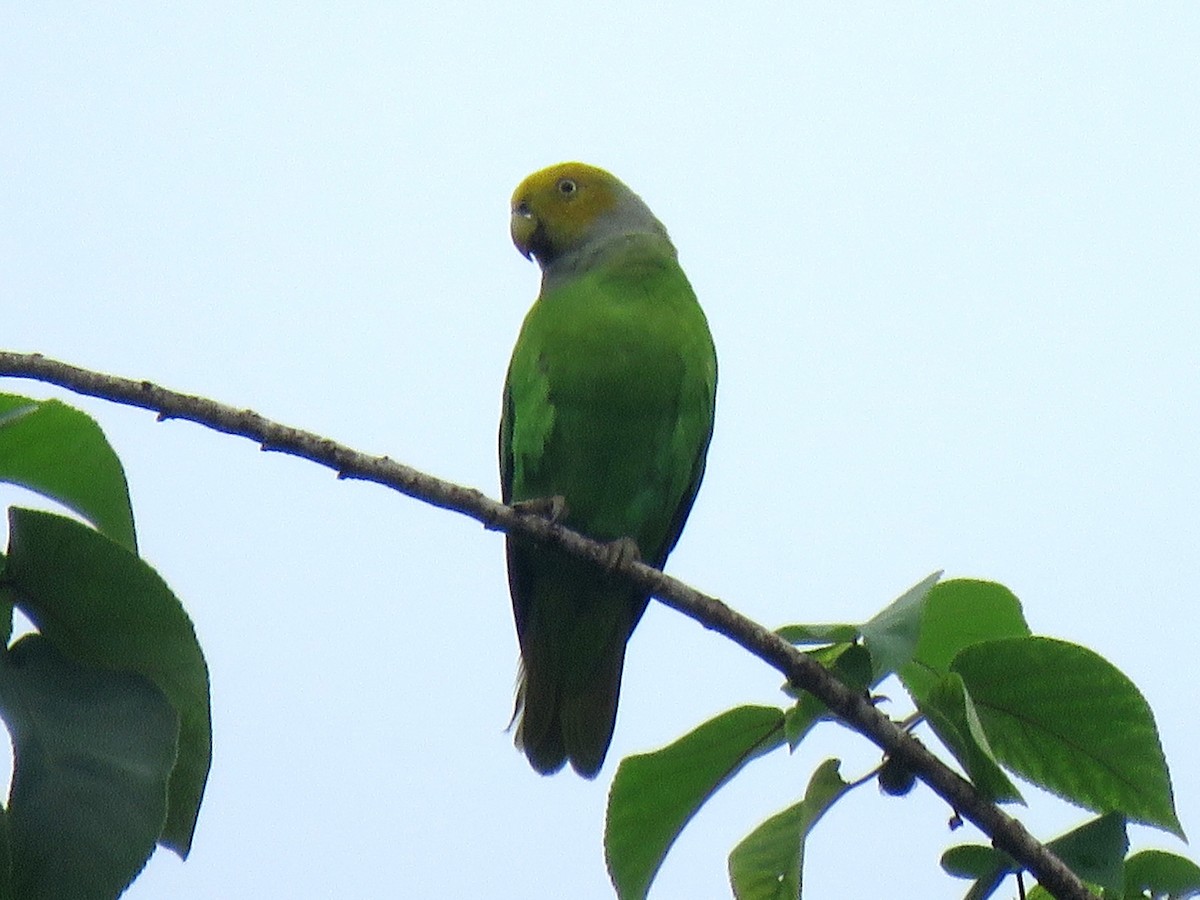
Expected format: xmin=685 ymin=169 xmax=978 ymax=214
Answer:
xmin=918 ymin=672 xmax=1024 ymax=803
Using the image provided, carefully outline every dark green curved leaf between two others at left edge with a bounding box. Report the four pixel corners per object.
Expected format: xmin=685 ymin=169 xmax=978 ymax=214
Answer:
xmin=6 ymin=508 xmax=211 ymax=857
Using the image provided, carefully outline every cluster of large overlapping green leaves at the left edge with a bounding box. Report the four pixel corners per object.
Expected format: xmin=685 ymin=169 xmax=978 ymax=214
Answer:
xmin=0 ymin=395 xmax=211 ymax=900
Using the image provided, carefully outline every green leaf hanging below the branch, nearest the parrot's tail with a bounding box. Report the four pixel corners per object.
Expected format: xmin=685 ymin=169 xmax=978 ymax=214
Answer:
xmin=605 ymin=707 xmax=784 ymax=900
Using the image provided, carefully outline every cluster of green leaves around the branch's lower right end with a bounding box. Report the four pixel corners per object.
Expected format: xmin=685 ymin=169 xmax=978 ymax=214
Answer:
xmin=605 ymin=575 xmax=1200 ymax=900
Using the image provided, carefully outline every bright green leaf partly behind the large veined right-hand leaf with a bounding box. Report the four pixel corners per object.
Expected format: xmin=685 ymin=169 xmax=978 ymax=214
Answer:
xmin=900 ymin=578 xmax=1030 ymax=703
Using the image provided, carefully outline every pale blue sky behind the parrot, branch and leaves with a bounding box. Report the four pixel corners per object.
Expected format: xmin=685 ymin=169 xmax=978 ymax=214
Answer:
xmin=0 ymin=2 xmax=1200 ymax=899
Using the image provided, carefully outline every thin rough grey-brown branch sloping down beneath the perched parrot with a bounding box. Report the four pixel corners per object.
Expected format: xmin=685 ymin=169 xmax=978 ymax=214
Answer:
xmin=0 ymin=350 xmax=1094 ymax=900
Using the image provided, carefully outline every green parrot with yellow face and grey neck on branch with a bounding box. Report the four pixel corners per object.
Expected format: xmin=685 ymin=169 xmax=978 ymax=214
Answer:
xmin=499 ymin=162 xmax=716 ymax=778
